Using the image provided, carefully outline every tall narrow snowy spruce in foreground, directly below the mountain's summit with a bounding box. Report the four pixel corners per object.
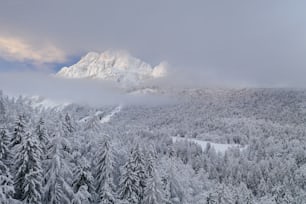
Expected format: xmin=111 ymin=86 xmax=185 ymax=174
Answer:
xmin=95 ymin=137 xmax=116 ymax=204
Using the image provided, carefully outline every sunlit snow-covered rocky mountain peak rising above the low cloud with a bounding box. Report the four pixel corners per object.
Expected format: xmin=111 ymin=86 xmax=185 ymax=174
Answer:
xmin=56 ymin=50 xmax=167 ymax=86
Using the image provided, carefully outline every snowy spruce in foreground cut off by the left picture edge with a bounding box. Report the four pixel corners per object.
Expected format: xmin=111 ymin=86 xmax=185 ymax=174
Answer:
xmin=0 ymin=129 xmax=14 ymax=204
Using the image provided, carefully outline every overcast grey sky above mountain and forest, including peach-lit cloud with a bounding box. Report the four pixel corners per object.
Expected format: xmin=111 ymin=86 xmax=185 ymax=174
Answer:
xmin=0 ymin=0 xmax=306 ymax=87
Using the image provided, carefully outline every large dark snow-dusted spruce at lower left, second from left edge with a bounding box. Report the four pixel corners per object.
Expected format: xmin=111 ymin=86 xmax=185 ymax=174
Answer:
xmin=14 ymin=132 xmax=42 ymax=204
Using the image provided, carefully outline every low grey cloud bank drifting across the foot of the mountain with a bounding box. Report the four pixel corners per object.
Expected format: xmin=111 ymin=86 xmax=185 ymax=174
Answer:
xmin=0 ymin=72 xmax=173 ymax=106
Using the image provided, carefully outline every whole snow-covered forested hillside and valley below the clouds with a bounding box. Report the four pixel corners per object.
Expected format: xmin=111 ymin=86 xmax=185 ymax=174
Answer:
xmin=0 ymin=89 xmax=306 ymax=204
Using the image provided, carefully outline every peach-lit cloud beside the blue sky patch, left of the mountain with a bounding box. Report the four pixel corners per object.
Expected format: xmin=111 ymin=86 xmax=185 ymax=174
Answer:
xmin=0 ymin=36 xmax=67 ymax=65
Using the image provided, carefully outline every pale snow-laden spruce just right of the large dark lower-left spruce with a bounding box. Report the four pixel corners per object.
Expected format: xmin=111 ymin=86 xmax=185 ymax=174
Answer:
xmin=43 ymin=133 xmax=74 ymax=204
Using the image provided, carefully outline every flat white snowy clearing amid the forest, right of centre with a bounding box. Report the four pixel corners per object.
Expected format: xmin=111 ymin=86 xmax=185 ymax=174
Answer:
xmin=172 ymin=137 xmax=246 ymax=153
